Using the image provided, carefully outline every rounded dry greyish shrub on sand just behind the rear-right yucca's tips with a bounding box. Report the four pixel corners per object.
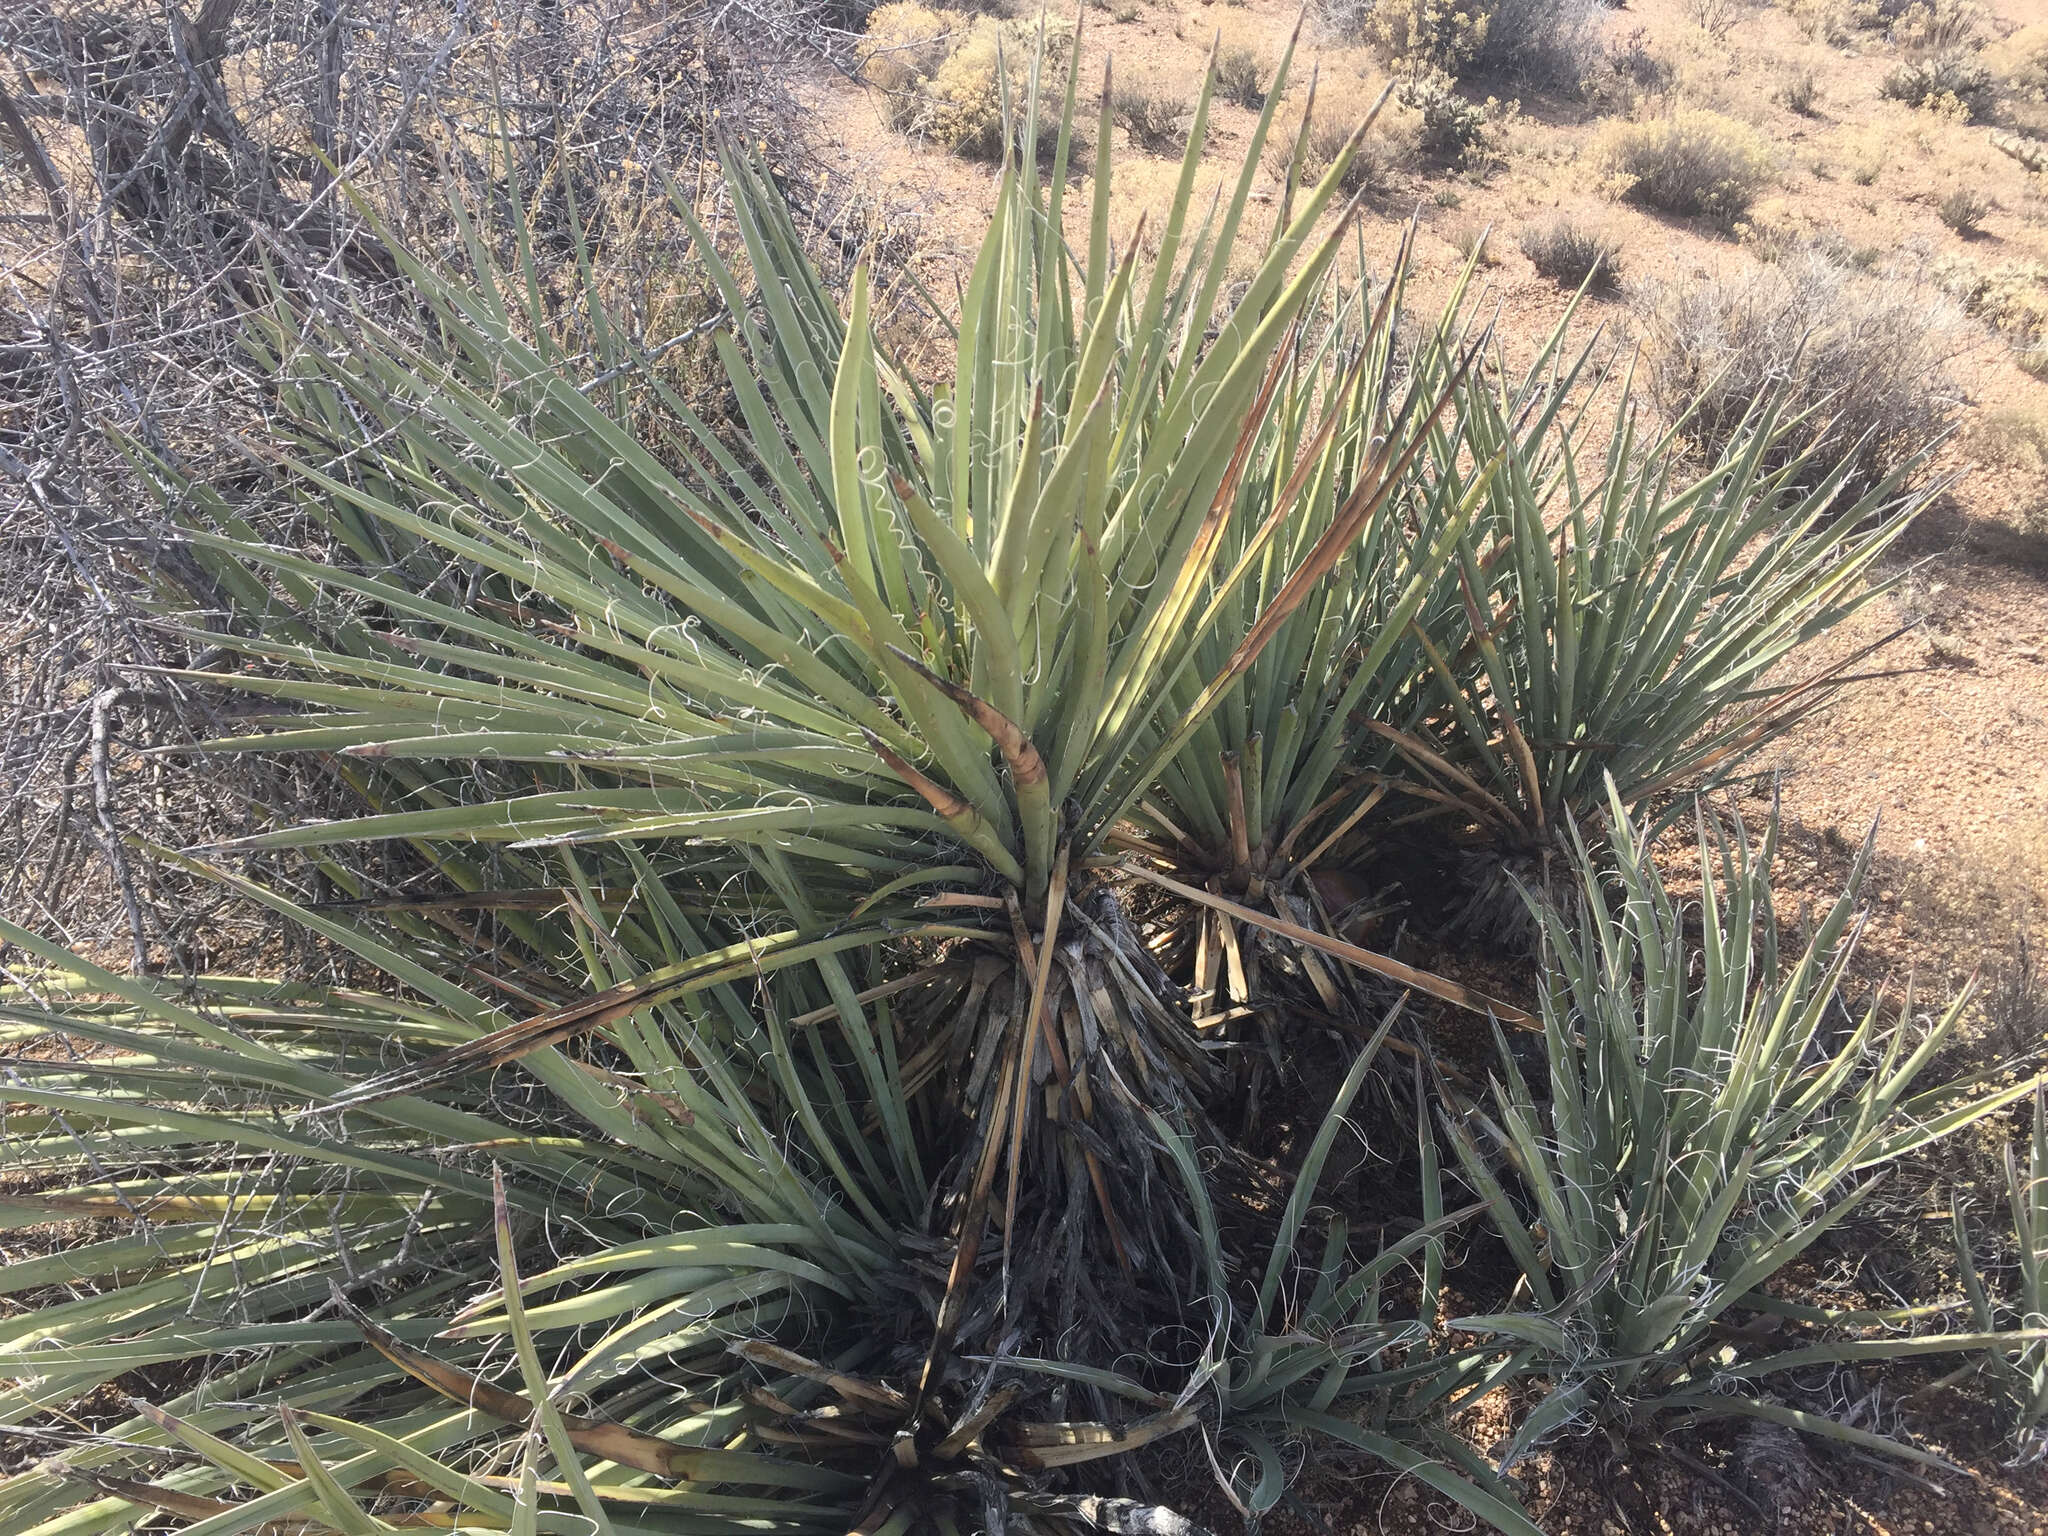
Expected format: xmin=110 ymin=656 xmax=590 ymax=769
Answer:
xmin=1636 ymin=254 xmax=1962 ymax=492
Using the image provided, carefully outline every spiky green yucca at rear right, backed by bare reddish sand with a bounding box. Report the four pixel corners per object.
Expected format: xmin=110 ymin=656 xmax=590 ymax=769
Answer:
xmin=1372 ymin=354 xmax=1929 ymax=872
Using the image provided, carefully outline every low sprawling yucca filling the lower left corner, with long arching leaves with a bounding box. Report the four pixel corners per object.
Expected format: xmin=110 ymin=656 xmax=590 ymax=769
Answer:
xmin=0 ymin=877 xmax=924 ymax=1532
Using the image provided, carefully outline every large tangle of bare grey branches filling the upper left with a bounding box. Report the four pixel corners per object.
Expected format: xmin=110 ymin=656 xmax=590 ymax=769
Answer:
xmin=0 ymin=0 xmax=815 ymax=971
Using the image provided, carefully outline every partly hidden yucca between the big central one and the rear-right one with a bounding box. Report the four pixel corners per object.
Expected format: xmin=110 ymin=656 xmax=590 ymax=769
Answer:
xmin=1106 ymin=237 xmax=1518 ymax=1026
